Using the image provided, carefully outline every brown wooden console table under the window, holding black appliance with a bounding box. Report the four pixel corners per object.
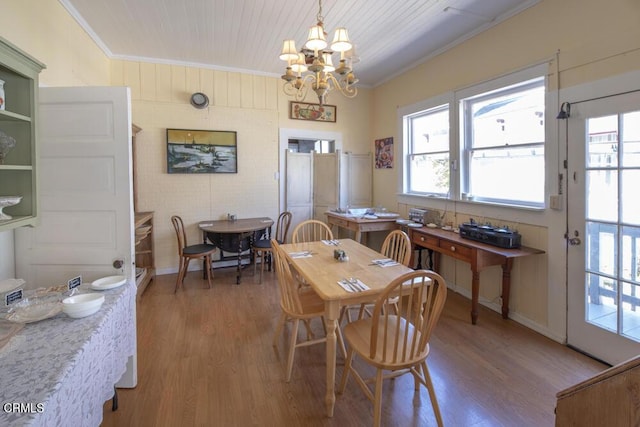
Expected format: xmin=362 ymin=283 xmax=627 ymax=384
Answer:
xmin=409 ymin=227 xmax=544 ymax=325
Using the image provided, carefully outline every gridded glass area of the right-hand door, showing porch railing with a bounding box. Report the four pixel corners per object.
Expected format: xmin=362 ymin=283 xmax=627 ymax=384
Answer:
xmin=585 ymin=111 xmax=640 ymax=341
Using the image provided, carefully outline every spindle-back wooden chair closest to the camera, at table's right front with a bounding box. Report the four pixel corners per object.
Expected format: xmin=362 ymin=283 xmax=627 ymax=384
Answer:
xmin=338 ymin=270 xmax=447 ymax=427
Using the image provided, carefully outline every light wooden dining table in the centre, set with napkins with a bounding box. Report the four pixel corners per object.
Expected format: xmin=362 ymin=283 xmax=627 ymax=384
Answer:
xmin=281 ymin=239 xmax=413 ymax=417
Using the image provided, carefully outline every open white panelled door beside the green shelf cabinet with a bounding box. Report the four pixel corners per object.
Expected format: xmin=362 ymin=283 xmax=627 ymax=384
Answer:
xmin=16 ymin=87 xmax=135 ymax=287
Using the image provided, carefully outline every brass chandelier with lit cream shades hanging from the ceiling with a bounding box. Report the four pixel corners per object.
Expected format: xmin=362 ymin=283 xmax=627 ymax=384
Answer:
xmin=280 ymin=0 xmax=358 ymax=105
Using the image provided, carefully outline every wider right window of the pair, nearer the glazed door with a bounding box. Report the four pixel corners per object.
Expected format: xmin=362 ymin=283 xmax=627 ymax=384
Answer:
xmin=460 ymin=78 xmax=545 ymax=211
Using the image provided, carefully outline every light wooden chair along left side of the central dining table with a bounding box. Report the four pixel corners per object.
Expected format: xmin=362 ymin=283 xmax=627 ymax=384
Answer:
xmin=271 ymin=239 xmax=346 ymax=382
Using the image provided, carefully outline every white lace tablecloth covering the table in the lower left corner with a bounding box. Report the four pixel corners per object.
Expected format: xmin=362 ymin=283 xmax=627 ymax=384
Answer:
xmin=0 ymin=283 xmax=136 ymax=427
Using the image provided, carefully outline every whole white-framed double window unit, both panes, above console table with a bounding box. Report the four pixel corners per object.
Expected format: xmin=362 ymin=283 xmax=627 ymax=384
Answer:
xmin=399 ymin=66 xmax=546 ymax=208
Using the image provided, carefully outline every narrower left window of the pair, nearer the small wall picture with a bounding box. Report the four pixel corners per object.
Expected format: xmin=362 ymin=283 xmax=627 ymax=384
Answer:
xmin=405 ymin=105 xmax=449 ymax=196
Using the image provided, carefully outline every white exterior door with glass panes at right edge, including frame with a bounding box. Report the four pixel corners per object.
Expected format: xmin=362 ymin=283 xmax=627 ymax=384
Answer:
xmin=566 ymin=92 xmax=640 ymax=364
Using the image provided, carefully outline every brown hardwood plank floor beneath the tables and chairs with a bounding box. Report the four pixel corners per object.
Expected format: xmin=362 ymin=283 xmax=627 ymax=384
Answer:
xmin=103 ymin=268 xmax=607 ymax=427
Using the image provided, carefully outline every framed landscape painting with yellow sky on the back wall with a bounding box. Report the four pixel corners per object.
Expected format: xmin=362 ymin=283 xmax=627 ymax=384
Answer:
xmin=167 ymin=129 xmax=238 ymax=173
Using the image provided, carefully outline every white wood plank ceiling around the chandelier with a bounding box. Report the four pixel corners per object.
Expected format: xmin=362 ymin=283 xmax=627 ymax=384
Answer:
xmin=59 ymin=0 xmax=540 ymax=86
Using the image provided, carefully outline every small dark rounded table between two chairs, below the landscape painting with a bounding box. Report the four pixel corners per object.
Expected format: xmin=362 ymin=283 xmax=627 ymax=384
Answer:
xmin=198 ymin=217 xmax=273 ymax=285
